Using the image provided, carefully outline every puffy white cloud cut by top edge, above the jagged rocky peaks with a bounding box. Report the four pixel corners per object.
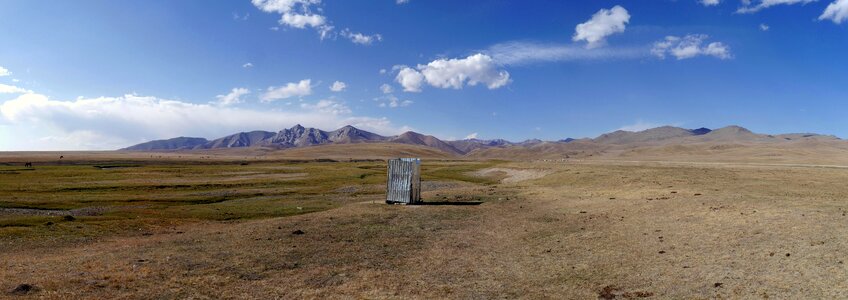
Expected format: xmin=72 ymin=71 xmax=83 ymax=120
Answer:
xmin=251 ymin=0 xmax=333 ymax=39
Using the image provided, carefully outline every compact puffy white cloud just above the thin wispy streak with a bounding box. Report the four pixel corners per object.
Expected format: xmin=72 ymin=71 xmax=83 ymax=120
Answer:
xmin=571 ymin=5 xmax=630 ymax=48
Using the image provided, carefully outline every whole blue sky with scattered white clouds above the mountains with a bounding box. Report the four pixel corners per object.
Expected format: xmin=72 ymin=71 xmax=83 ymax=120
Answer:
xmin=0 ymin=0 xmax=848 ymax=151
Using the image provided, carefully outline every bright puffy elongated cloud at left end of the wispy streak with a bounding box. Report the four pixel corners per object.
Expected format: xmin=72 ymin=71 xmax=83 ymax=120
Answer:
xmin=395 ymin=53 xmax=510 ymax=92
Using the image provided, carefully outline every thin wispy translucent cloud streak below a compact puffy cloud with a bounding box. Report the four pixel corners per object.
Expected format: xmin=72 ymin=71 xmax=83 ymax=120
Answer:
xmin=484 ymin=41 xmax=650 ymax=65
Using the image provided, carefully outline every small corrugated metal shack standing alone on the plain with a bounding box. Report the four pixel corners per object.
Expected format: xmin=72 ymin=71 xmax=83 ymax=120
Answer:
xmin=386 ymin=158 xmax=421 ymax=204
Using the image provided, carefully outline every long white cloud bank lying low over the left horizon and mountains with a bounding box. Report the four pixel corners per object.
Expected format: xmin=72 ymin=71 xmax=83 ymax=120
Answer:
xmin=0 ymin=93 xmax=408 ymax=150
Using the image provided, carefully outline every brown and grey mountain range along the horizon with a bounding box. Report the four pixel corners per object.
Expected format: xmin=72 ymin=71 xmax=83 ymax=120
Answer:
xmin=121 ymin=125 xmax=839 ymax=156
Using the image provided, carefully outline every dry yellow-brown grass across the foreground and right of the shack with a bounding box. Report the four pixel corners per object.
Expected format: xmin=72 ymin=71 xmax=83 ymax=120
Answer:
xmin=0 ymin=150 xmax=848 ymax=299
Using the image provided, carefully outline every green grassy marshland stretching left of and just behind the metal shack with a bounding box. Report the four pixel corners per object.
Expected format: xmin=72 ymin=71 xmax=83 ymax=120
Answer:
xmin=0 ymin=161 xmax=500 ymax=251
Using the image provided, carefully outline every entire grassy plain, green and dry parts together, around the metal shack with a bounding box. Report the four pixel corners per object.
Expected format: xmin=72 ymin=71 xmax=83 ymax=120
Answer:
xmin=0 ymin=154 xmax=848 ymax=299
